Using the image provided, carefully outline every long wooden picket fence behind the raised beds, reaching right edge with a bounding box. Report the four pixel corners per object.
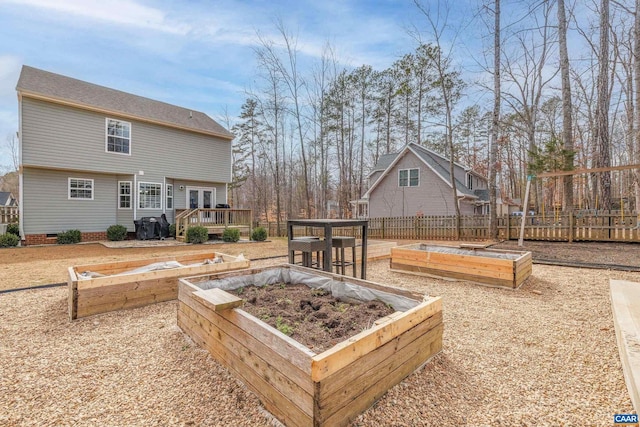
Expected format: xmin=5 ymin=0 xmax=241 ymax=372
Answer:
xmin=258 ymin=211 xmax=640 ymax=242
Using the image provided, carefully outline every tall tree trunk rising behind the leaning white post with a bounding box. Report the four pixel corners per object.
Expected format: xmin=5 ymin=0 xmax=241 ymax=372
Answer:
xmin=558 ymin=0 xmax=576 ymax=212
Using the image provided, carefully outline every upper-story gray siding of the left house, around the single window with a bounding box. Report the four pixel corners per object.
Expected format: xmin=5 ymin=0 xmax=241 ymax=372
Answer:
xmin=21 ymin=97 xmax=231 ymax=183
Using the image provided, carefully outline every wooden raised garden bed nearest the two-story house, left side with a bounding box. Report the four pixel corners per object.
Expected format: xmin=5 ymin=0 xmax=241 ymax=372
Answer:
xmin=67 ymin=251 xmax=249 ymax=320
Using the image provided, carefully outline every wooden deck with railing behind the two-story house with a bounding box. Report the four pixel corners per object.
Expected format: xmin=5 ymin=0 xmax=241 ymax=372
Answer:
xmin=176 ymin=209 xmax=253 ymax=242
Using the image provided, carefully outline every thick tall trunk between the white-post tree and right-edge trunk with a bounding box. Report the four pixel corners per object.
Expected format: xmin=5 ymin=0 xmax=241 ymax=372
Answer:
xmin=594 ymin=0 xmax=611 ymax=210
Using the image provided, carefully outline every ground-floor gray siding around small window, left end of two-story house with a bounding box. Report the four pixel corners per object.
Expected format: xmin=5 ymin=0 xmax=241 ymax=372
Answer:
xmin=23 ymin=168 xmax=117 ymax=234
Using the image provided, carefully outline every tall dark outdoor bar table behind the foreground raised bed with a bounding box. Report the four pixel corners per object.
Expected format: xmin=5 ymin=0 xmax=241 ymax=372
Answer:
xmin=287 ymin=219 xmax=369 ymax=279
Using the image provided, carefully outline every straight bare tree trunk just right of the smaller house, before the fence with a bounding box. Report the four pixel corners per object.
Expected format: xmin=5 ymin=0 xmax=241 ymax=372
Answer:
xmin=489 ymin=0 xmax=500 ymax=240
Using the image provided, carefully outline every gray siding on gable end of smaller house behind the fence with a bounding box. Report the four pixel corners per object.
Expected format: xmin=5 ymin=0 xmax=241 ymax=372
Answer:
xmin=369 ymin=152 xmax=462 ymax=218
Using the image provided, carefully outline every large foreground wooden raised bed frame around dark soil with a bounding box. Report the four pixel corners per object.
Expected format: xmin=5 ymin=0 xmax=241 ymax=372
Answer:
xmin=178 ymin=264 xmax=443 ymax=426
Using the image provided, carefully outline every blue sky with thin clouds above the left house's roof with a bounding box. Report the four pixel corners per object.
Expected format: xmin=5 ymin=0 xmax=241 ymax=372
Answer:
xmin=0 ymin=0 xmax=472 ymax=171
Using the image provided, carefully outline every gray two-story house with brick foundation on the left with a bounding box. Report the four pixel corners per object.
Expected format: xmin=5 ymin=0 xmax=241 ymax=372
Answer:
xmin=16 ymin=66 xmax=233 ymax=245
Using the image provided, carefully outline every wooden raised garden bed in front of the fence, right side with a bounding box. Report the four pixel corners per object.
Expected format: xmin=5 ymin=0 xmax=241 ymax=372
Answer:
xmin=391 ymin=243 xmax=531 ymax=289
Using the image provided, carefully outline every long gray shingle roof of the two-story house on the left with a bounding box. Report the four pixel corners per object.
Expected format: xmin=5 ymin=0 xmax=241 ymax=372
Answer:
xmin=16 ymin=65 xmax=233 ymax=139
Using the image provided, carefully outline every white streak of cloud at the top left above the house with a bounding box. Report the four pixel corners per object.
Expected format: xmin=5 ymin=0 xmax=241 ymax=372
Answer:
xmin=5 ymin=0 xmax=190 ymax=34
